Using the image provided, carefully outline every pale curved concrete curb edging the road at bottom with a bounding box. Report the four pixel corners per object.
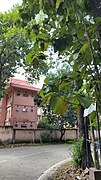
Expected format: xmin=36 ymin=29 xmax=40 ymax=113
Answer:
xmin=37 ymin=158 xmax=72 ymax=180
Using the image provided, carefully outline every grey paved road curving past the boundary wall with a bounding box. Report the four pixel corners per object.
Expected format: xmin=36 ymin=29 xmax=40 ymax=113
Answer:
xmin=0 ymin=145 xmax=70 ymax=180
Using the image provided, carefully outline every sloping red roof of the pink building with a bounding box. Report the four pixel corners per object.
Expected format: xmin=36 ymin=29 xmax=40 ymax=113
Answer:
xmin=9 ymin=78 xmax=40 ymax=92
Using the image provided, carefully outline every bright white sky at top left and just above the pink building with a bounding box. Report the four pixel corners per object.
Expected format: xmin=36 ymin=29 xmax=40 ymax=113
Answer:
xmin=0 ymin=0 xmax=45 ymax=88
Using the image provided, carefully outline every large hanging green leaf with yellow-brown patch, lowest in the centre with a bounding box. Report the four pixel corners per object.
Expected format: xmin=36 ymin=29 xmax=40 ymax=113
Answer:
xmin=50 ymin=96 xmax=67 ymax=114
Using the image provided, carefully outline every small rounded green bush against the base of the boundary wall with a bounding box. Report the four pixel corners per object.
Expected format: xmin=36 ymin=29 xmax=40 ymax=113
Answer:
xmin=40 ymin=131 xmax=52 ymax=143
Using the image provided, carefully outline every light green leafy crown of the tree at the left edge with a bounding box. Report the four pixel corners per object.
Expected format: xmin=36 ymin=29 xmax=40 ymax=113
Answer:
xmin=0 ymin=9 xmax=30 ymax=98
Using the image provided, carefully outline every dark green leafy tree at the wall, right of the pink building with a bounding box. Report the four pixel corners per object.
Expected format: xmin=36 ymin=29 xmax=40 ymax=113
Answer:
xmin=38 ymin=105 xmax=77 ymax=141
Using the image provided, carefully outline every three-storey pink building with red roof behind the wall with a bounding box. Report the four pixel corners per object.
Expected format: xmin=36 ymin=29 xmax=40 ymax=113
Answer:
xmin=0 ymin=78 xmax=42 ymax=129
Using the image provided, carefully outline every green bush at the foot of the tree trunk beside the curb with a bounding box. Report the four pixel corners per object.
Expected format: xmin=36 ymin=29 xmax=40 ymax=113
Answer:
xmin=72 ymin=138 xmax=83 ymax=168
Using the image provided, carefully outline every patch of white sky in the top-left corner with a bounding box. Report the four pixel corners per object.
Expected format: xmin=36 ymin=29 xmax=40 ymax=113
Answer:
xmin=0 ymin=0 xmax=22 ymax=12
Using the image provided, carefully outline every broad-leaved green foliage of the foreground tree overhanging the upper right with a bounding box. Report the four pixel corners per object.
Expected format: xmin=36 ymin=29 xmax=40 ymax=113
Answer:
xmin=17 ymin=0 xmax=101 ymax=169
